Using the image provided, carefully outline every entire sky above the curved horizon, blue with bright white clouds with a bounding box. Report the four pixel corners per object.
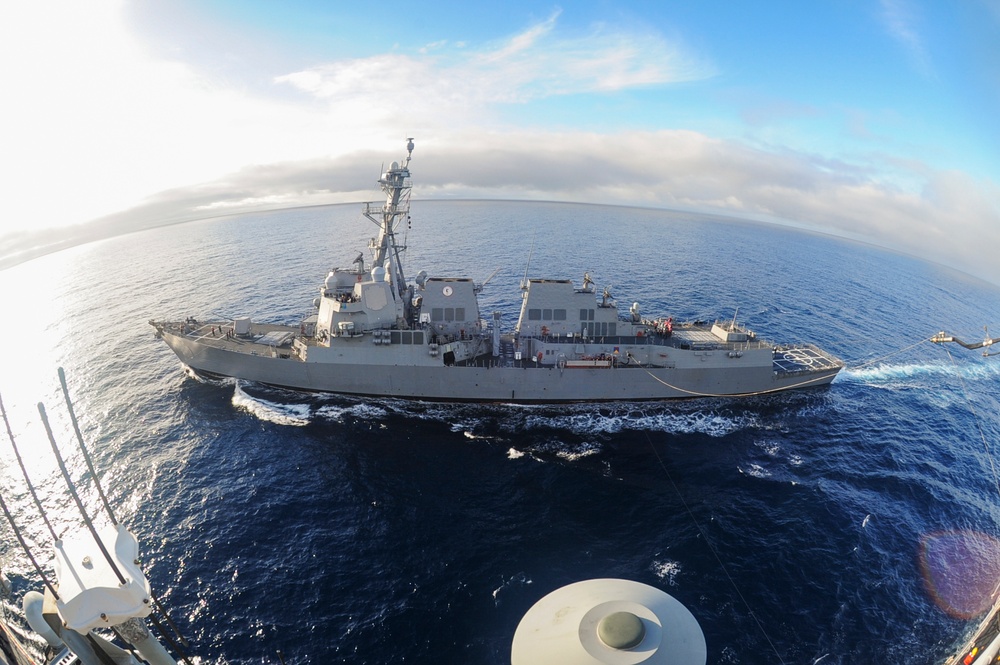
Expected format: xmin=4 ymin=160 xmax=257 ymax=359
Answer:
xmin=0 ymin=0 xmax=1000 ymax=283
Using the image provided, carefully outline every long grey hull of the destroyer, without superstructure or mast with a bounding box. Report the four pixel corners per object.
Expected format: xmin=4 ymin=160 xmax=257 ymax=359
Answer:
xmin=160 ymin=330 xmax=840 ymax=403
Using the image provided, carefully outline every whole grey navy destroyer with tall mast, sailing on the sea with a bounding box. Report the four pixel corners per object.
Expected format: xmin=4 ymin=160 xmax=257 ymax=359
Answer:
xmin=150 ymin=139 xmax=844 ymax=403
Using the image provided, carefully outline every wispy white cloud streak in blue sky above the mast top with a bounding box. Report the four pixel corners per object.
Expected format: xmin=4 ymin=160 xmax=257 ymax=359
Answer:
xmin=277 ymin=15 xmax=715 ymax=112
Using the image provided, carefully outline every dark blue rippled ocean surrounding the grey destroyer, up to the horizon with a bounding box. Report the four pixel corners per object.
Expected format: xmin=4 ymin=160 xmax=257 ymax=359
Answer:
xmin=0 ymin=201 xmax=1000 ymax=665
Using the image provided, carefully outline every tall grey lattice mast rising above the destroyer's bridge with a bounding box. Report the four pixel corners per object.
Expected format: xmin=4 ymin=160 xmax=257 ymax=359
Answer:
xmin=364 ymin=138 xmax=413 ymax=296
